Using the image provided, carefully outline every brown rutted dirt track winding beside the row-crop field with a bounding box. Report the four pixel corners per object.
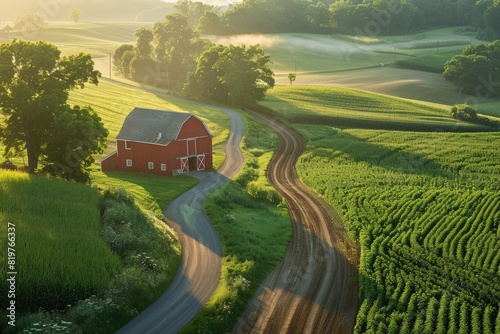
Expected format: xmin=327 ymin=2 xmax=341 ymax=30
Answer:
xmin=233 ymin=112 xmax=358 ymax=334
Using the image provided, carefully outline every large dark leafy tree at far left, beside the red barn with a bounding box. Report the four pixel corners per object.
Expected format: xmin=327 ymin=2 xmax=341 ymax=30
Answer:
xmin=0 ymin=40 xmax=107 ymax=181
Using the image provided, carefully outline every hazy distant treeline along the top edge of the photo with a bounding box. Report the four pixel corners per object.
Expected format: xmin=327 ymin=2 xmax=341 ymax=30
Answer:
xmin=187 ymin=0 xmax=500 ymax=39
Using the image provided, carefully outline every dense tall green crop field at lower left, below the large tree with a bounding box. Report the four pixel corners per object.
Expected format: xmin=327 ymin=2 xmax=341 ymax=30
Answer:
xmin=0 ymin=171 xmax=121 ymax=312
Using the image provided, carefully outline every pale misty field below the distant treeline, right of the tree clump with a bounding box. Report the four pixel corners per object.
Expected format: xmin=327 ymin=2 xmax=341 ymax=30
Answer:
xmin=248 ymin=28 xmax=480 ymax=75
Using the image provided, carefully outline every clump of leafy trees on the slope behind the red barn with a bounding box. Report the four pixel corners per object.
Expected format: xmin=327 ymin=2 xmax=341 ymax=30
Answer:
xmin=114 ymin=13 xmax=274 ymax=106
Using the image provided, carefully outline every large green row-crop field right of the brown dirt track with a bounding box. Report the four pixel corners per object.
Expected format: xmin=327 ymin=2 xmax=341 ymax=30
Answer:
xmin=263 ymin=88 xmax=500 ymax=333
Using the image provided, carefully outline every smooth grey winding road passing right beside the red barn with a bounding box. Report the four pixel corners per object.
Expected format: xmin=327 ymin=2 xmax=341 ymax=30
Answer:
xmin=118 ymin=107 xmax=243 ymax=334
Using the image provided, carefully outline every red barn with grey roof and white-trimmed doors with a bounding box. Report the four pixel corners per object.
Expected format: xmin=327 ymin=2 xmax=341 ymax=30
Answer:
xmin=101 ymin=108 xmax=212 ymax=176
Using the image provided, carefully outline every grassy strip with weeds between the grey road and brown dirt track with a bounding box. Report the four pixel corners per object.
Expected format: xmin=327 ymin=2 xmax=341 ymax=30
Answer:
xmin=183 ymin=109 xmax=292 ymax=333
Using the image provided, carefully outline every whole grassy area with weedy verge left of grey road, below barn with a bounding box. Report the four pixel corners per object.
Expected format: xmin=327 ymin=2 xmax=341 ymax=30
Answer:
xmin=0 ymin=172 xmax=198 ymax=333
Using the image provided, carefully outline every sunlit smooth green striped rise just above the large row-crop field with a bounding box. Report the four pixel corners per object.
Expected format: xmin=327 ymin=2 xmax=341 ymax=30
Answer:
xmin=259 ymin=86 xmax=490 ymax=131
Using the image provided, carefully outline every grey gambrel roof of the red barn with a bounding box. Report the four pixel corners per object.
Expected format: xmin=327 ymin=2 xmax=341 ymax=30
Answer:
xmin=116 ymin=108 xmax=210 ymax=145
